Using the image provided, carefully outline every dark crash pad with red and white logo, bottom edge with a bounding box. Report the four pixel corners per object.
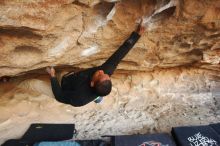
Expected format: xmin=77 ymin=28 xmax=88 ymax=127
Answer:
xmin=111 ymin=133 xmax=175 ymax=146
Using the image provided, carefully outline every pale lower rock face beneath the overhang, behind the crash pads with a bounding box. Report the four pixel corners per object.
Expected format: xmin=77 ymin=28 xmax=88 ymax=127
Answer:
xmin=0 ymin=68 xmax=220 ymax=144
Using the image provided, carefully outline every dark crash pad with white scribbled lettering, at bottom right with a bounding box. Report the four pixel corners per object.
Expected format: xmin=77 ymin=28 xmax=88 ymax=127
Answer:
xmin=172 ymin=126 xmax=220 ymax=146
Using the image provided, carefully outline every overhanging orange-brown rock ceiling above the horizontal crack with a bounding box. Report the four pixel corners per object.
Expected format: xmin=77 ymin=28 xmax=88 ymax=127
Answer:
xmin=0 ymin=0 xmax=220 ymax=76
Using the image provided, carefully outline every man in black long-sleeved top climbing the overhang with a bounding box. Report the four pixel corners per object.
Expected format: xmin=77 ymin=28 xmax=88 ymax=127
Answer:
xmin=47 ymin=21 xmax=145 ymax=106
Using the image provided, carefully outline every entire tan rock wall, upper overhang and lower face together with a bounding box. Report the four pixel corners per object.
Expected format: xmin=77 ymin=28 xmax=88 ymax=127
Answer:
xmin=0 ymin=0 xmax=220 ymax=144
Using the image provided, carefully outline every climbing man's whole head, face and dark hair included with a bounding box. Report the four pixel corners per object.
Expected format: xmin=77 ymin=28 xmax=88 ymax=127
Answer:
xmin=91 ymin=70 xmax=112 ymax=96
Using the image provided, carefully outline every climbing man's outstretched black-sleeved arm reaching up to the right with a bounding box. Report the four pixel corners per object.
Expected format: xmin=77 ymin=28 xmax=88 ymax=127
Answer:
xmin=101 ymin=21 xmax=145 ymax=75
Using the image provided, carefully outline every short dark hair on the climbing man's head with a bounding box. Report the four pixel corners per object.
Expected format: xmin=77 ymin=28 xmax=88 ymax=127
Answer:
xmin=95 ymin=80 xmax=112 ymax=96
